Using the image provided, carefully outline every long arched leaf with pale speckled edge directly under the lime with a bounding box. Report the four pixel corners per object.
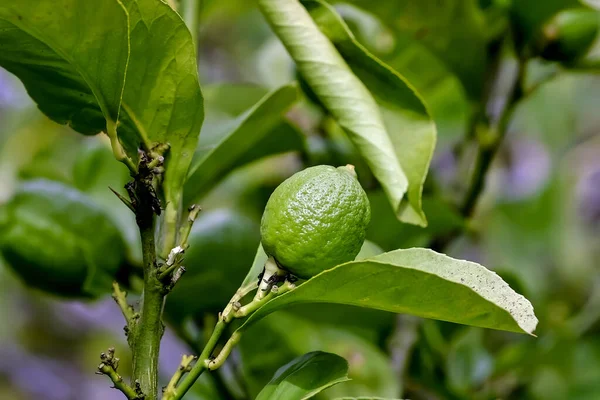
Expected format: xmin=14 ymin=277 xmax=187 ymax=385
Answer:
xmin=240 ymin=248 xmax=537 ymax=334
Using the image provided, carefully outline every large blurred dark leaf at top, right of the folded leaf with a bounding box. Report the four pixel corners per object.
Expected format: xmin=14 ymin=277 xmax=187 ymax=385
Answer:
xmin=336 ymin=0 xmax=487 ymax=98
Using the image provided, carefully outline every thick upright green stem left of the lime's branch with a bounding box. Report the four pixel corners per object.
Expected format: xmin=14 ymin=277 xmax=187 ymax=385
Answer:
xmin=132 ymin=218 xmax=165 ymax=400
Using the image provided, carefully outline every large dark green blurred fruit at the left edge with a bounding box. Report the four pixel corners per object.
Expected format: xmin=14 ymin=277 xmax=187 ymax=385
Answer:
xmin=0 ymin=180 xmax=125 ymax=298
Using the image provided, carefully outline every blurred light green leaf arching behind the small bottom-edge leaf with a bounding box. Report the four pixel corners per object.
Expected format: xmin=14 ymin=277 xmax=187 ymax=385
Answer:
xmin=240 ymin=311 xmax=400 ymax=399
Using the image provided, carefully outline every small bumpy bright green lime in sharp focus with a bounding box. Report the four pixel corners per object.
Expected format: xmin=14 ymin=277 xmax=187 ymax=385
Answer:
xmin=260 ymin=165 xmax=371 ymax=279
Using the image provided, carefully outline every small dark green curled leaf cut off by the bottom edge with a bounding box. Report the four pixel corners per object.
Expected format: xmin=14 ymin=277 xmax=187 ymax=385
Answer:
xmin=256 ymin=351 xmax=348 ymax=400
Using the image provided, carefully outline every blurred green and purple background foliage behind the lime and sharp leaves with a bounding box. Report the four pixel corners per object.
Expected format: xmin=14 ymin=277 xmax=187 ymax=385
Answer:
xmin=0 ymin=0 xmax=600 ymax=400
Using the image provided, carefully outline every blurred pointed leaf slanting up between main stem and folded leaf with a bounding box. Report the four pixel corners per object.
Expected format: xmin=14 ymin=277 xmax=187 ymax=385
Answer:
xmin=185 ymin=85 xmax=303 ymax=204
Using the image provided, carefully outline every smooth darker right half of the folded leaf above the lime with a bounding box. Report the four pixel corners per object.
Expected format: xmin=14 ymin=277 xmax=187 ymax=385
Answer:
xmin=302 ymin=0 xmax=437 ymax=226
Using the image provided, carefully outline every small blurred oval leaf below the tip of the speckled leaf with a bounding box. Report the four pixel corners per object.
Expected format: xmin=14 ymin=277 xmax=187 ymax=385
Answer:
xmin=446 ymin=328 xmax=494 ymax=396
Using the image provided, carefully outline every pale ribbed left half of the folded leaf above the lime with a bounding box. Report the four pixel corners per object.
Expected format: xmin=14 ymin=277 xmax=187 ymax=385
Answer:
xmin=258 ymin=0 xmax=408 ymax=222
